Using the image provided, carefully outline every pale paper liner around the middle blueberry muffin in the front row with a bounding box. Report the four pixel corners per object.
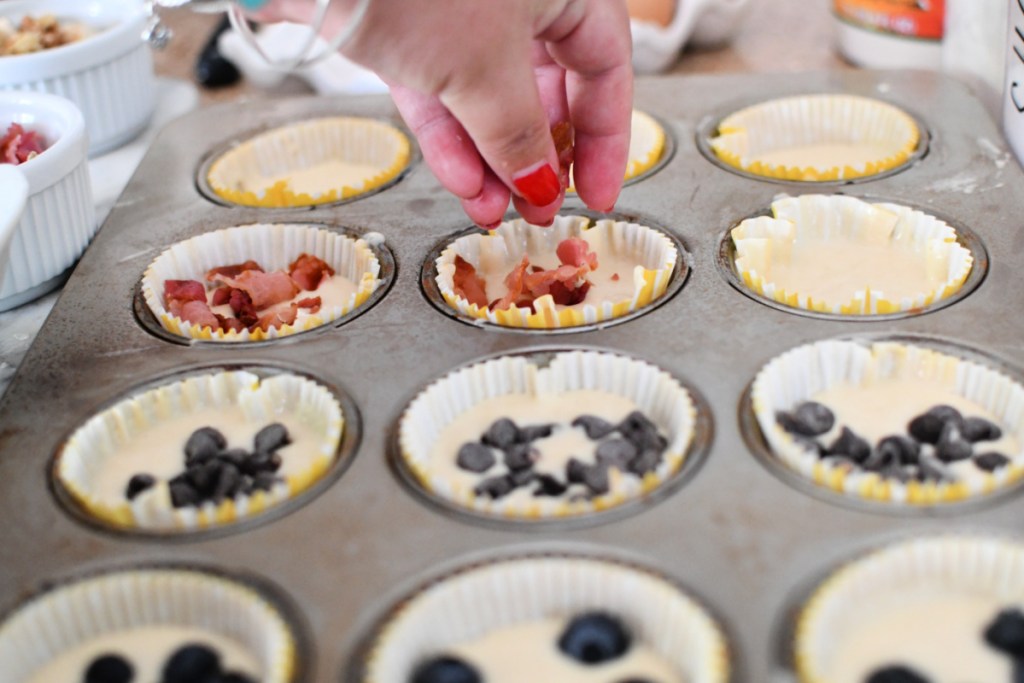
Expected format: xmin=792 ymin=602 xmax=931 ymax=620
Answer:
xmin=364 ymin=557 xmax=729 ymax=683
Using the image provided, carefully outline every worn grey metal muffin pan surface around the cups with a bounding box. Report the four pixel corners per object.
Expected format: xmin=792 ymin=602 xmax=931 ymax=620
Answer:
xmin=0 ymin=71 xmax=1024 ymax=683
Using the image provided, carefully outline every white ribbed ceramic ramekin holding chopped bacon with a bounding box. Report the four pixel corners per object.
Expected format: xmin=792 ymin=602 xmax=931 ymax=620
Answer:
xmin=0 ymin=91 xmax=96 ymax=310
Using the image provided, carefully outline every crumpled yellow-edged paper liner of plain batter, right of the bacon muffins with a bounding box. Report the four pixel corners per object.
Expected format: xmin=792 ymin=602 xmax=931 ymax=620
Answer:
xmin=730 ymin=195 xmax=974 ymax=315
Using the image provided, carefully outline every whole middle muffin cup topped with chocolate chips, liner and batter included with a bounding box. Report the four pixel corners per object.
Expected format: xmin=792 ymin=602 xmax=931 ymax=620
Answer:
xmin=393 ymin=350 xmax=712 ymax=527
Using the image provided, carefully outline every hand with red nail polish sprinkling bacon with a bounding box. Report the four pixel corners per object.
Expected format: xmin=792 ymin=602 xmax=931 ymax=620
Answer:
xmin=244 ymin=0 xmax=633 ymax=227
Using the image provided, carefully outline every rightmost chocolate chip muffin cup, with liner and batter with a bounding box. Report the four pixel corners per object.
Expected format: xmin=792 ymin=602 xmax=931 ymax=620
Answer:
xmin=740 ymin=337 xmax=1024 ymax=513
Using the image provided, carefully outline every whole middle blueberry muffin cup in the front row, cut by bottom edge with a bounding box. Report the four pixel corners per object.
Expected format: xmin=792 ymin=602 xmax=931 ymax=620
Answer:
xmin=346 ymin=553 xmax=731 ymax=683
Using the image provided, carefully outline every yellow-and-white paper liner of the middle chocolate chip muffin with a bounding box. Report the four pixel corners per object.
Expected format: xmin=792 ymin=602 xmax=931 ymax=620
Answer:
xmin=398 ymin=351 xmax=696 ymax=520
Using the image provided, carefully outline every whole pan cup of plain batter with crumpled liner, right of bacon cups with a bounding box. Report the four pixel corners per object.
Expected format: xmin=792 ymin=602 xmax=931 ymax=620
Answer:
xmin=716 ymin=194 xmax=988 ymax=322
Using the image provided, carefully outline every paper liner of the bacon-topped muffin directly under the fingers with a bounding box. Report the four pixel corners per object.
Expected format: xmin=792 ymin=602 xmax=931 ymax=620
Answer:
xmin=435 ymin=216 xmax=679 ymax=329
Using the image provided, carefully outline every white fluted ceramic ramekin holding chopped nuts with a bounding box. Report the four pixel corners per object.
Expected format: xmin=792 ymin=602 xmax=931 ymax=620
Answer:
xmin=0 ymin=0 xmax=156 ymax=155
